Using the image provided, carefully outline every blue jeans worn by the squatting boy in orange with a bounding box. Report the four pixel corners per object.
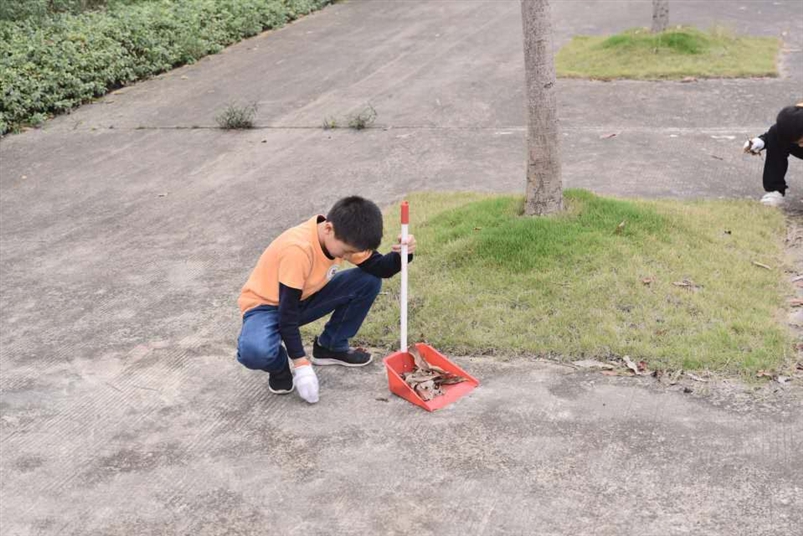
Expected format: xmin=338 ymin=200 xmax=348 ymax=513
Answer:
xmin=237 ymin=268 xmax=382 ymax=372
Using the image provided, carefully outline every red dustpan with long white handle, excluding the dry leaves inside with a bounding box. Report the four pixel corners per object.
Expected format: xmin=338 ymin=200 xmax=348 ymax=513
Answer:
xmin=384 ymin=201 xmax=480 ymax=411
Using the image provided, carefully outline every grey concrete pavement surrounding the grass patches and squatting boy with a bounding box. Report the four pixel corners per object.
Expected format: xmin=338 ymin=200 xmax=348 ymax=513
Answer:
xmin=0 ymin=0 xmax=803 ymax=536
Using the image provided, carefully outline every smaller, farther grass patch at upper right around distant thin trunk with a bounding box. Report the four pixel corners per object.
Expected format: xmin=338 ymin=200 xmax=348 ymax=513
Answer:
xmin=555 ymin=26 xmax=780 ymax=80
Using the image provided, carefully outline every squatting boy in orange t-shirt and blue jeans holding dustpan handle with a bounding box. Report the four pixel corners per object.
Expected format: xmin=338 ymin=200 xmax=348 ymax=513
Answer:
xmin=237 ymin=196 xmax=415 ymax=404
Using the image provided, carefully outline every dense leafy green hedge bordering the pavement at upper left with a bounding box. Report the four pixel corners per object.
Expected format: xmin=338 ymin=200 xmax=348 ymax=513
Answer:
xmin=0 ymin=0 xmax=332 ymax=134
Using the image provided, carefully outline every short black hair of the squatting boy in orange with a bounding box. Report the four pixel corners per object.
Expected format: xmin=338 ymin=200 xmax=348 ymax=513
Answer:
xmin=326 ymin=195 xmax=383 ymax=251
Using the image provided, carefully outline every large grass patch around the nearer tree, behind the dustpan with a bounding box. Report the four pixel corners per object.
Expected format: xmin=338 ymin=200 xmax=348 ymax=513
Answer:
xmin=322 ymin=190 xmax=792 ymax=373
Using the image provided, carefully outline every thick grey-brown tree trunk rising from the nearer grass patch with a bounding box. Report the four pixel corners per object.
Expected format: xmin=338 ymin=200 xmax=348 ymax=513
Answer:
xmin=521 ymin=0 xmax=563 ymax=216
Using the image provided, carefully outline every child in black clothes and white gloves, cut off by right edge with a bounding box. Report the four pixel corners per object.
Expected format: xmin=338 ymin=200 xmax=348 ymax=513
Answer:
xmin=744 ymin=102 xmax=803 ymax=207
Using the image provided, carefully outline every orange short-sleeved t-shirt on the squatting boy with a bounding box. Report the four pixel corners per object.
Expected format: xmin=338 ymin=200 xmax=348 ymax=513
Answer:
xmin=237 ymin=216 xmax=372 ymax=314
